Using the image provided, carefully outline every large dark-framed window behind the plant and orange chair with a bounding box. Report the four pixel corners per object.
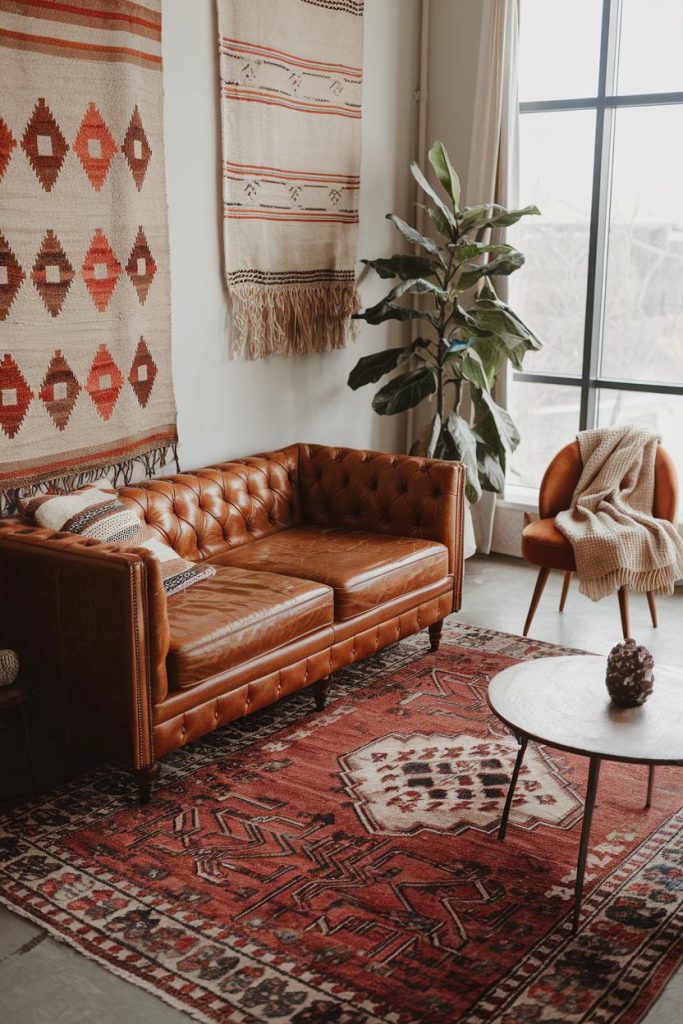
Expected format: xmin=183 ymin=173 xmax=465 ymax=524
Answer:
xmin=509 ymin=0 xmax=683 ymax=488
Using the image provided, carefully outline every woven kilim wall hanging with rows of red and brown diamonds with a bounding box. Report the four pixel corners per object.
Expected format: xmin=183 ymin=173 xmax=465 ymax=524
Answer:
xmin=0 ymin=0 xmax=176 ymax=512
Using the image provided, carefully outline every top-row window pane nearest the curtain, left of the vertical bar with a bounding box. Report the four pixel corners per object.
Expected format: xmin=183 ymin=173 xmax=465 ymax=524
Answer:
xmin=519 ymin=0 xmax=602 ymax=102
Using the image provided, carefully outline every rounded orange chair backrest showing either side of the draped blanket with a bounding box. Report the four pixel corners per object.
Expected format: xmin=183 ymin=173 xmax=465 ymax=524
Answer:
xmin=539 ymin=441 xmax=678 ymax=523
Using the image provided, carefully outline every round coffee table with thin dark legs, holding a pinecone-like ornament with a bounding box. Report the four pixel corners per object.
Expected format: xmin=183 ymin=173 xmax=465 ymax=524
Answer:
xmin=488 ymin=654 xmax=683 ymax=932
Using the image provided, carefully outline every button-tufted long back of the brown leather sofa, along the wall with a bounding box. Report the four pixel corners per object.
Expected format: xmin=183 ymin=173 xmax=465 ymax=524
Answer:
xmin=120 ymin=445 xmax=300 ymax=561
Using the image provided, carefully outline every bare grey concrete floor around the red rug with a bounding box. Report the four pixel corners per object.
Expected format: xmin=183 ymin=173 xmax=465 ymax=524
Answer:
xmin=0 ymin=555 xmax=683 ymax=1024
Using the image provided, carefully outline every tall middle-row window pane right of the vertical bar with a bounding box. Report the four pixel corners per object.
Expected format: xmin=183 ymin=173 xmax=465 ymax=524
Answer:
xmin=598 ymin=105 xmax=683 ymax=383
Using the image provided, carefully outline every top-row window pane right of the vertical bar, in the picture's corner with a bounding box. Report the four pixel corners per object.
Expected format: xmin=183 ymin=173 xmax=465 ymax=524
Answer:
xmin=617 ymin=0 xmax=683 ymax=95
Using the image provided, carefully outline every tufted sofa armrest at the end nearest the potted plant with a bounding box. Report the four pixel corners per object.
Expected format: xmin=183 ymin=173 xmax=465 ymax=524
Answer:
xmin=298 ymin=444 xmax=465 ymax=609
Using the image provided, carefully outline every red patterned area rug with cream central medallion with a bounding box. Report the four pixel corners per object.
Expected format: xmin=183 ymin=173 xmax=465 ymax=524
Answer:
xmin=0 ymin=626 xmax=683 ymax=1024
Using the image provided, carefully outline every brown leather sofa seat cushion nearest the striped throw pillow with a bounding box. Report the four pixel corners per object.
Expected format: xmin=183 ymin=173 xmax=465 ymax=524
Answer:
xmin=166 ymin=566 xmax=334 ymax=690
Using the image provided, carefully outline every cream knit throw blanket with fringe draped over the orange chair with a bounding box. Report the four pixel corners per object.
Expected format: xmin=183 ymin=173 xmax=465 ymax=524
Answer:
xmin=555 ymin=427 xmax=683 ymax=601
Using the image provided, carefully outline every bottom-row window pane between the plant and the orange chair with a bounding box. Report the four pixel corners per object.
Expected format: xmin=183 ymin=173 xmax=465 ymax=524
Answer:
xmin=508 ymin=381 xmax=581 ymax=487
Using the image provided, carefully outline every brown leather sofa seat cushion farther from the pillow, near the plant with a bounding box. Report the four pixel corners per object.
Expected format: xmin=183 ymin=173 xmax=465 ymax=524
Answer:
xmin=212 ymin=526 xmax=449 ymax=622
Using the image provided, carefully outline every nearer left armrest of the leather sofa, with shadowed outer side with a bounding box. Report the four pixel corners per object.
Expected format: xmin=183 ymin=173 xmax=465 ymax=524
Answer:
xmin=0 ymin=523 xmax=168 ymax=768
